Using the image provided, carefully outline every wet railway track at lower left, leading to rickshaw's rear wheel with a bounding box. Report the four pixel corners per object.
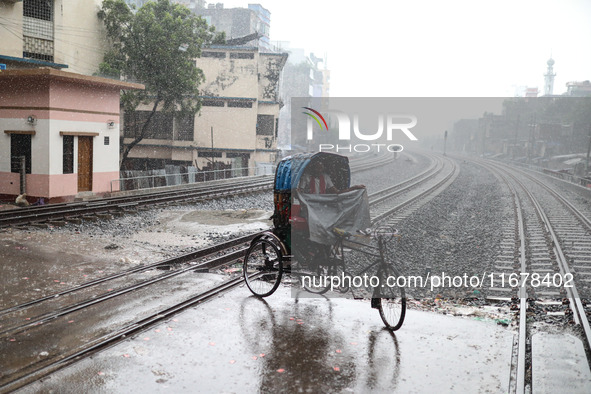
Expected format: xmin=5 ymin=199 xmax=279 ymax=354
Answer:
xmin=0 ymin=235 xmax=254 ymax=392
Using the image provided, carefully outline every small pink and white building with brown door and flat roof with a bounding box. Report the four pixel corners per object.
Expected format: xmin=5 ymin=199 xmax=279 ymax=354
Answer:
xmin=0 ymin=68 xmax=144 ymax=202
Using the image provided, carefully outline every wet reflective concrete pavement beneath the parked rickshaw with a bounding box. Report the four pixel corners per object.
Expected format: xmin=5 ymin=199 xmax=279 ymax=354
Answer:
xmin=21 ymin=286 xmax=514 ymax=393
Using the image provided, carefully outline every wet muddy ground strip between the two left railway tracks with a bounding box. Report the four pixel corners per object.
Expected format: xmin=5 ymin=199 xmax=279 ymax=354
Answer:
xmin=0 ymin=207 xmax=271 ymax=309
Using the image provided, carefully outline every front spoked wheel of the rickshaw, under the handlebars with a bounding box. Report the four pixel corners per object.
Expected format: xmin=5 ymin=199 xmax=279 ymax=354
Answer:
xmin=372 ymin=268 xmax=406 ymax=331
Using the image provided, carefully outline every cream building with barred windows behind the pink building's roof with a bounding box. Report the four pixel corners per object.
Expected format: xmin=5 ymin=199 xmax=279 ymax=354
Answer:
xmin=0 ymin=0 xmax=106 ymax=75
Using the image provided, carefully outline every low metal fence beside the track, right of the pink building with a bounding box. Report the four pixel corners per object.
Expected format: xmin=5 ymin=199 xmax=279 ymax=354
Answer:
xmin=111 ymin=165 xmax=275 ymax=192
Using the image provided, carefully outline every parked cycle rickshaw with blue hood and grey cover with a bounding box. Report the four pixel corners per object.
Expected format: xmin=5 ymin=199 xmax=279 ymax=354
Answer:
xmin=243 ymin=152 xmax=406 ymax=330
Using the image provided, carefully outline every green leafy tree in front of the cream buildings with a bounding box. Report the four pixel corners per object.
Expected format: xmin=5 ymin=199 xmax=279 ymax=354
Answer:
xmin=99 ymin=0 xmax=225 ymax=169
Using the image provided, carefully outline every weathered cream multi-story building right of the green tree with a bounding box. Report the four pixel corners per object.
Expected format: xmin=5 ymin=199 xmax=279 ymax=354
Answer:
xmin=124 ymin=45 xmax=287 ymax=169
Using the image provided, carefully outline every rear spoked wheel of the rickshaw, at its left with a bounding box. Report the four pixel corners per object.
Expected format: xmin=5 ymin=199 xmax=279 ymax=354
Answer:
xmin=243 ymin=237 xmax=283 ymax=297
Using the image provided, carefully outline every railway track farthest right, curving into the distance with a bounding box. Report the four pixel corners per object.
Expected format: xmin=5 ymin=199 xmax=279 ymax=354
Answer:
xmin=476 ymin=160 xmax=591 ymax=393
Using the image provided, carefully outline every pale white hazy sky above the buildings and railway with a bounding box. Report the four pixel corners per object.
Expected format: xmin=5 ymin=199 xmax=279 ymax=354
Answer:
xmin=222 ymin=0 xmax=591 ymax=97
